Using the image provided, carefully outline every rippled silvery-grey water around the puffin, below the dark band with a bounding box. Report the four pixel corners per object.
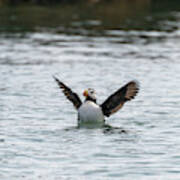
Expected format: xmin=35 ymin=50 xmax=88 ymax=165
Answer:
xmin=0 ymin=0 xmax=180 ymax=180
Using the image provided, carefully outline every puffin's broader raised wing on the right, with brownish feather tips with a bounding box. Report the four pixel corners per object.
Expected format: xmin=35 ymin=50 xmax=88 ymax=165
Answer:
xmin=101 ymin=81 xmax=139 ymax=116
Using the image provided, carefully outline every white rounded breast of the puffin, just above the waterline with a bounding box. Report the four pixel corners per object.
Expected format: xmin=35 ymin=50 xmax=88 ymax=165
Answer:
xmin=78 ymin=101 xmax=104 ymax=124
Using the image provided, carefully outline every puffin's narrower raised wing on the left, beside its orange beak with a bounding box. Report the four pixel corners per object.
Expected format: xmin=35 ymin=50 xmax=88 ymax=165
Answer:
xmin=53 ymin=76 xmax=82 ymax=109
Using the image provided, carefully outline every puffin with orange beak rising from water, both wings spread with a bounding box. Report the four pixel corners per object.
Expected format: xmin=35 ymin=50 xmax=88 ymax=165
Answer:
xmin=53 ymin=76 xmax=139 ymax=126
